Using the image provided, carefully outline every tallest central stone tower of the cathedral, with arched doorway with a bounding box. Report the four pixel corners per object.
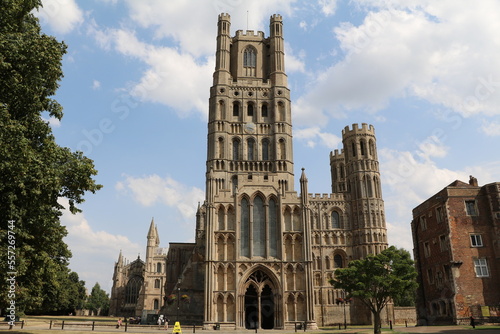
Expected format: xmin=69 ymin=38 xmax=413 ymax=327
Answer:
xmin=204 ymin=14 xmax=315 ymax=329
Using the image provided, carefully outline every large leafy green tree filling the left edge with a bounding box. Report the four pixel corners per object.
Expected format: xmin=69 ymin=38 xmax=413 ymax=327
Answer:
xmin=0 ymin=0 xmax=101 ymax=313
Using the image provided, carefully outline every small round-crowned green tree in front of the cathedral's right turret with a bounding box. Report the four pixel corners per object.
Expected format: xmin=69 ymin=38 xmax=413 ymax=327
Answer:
xmin=330 ymin=246 xmax=417 ymax=334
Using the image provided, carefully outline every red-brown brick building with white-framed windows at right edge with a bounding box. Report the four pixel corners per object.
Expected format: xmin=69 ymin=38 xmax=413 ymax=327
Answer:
xmin=411 ymin=176 xmax=500 ymax=325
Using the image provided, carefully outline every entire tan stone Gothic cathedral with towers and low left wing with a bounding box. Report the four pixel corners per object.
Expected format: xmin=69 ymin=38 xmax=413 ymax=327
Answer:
xmin=111 ymin=14 xmax=387 ymax=329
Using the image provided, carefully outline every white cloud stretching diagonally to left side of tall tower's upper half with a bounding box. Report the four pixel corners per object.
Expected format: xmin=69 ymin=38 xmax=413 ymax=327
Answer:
xmin=89 ymin=25 xmax=215 ymax=117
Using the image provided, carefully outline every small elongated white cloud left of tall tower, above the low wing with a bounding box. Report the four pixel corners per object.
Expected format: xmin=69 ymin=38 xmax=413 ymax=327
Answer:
xmin=115 ymin=174 xmax=205 ymax=221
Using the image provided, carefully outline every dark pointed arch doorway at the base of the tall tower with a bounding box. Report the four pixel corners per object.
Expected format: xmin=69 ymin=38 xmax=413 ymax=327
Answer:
xmin=243 ymin=270 xmax=277 ymax=329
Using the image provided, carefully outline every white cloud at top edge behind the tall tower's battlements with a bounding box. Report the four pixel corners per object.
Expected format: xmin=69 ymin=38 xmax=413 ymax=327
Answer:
xmin=128 ymin=0 xmax=293 ymax=57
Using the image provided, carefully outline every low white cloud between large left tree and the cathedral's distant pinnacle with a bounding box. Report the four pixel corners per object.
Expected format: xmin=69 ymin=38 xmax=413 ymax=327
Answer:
xmin=59 ymin=199 xmax=144 ymax=291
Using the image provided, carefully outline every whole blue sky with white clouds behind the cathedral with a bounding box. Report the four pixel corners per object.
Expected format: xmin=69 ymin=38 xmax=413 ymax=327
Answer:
xmin=36 ymin=0 xmax=500 ymax=292
